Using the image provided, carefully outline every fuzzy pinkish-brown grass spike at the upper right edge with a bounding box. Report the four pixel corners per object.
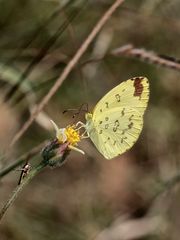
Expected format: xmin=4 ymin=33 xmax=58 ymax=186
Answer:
xmin=111 ymin=44 xmax=180 ymax=71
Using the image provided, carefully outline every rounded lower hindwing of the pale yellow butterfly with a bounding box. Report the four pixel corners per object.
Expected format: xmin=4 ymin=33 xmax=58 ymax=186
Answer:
xmin=90 ymin=107 xmax=143 ymax=159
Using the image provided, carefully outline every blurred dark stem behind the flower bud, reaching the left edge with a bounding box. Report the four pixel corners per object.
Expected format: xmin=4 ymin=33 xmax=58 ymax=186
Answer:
xmin=0 ymin=141 xmax=47 ymax=178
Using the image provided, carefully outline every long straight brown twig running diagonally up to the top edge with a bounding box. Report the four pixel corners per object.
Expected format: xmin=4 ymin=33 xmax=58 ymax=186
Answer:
xmin=11 ymin=0 xmax=125 ymax=146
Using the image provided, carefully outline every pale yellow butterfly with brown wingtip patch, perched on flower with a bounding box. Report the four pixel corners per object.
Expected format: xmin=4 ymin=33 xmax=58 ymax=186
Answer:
xmin=82 ymin=77 xmax=149 ymax=159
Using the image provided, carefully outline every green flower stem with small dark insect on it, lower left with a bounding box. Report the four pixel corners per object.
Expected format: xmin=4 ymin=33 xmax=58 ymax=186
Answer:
xmin=0 ymin=162 xmax=47 ymax=220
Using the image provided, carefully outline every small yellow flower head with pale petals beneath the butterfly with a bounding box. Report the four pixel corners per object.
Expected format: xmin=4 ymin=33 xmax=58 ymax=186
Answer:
xmin=51 ymin=120 xmax=84 ymax=154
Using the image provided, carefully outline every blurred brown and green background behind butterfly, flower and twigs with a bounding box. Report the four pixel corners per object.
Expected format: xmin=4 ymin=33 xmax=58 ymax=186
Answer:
xmin=0 ymin=0 xmax=180 ymax=240
